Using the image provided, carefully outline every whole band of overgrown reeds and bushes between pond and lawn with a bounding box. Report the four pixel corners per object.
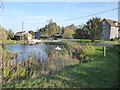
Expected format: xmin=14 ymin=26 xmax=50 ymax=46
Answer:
xmin=3 ymin=42 xmax=95 ymax=83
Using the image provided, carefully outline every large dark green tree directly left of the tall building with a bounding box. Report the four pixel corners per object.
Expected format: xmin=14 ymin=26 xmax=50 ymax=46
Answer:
xmin=83 ymin=17 xmax=102 ymax=42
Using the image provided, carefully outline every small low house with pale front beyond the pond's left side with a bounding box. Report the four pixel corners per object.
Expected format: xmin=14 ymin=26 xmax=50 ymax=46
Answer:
xmin=14 ymin=31 xmax=32 ymax=40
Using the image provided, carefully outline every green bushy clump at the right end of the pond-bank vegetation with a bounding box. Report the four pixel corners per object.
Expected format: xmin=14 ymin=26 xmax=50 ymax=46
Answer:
xmin=65 ymin=41 xmax=95 ymax=63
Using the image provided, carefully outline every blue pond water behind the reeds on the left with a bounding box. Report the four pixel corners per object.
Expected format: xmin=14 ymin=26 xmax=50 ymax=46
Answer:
xmin=5 ymin=44 xmax=48 ymax=61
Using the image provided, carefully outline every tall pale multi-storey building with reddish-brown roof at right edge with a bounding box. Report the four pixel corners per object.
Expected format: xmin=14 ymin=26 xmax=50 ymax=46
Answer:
xmin=101 ymin=19 xmax=120 ymax=40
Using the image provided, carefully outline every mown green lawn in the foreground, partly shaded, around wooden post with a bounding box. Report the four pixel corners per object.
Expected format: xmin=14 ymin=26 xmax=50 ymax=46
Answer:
xmin=3 ymin=46 xmax=118 ymax=88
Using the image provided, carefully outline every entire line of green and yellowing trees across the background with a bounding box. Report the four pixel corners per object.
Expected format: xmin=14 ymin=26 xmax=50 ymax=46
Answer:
xmin=0 ymin=17 xmax=102 ymax=42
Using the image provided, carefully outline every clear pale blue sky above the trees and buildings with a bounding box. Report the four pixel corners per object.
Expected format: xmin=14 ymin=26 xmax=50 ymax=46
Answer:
xmin=1 ymin=2 xmax=118 ymax=33
